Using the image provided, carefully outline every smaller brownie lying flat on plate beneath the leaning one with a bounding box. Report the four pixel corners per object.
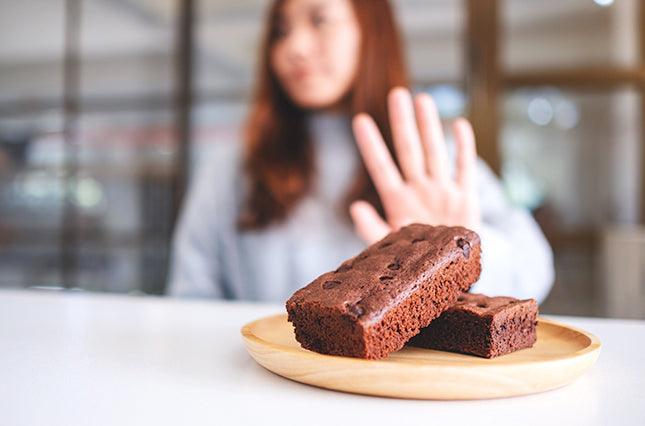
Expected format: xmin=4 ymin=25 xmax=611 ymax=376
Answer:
xmin=409 ymin=293 xmax=538 ymax=358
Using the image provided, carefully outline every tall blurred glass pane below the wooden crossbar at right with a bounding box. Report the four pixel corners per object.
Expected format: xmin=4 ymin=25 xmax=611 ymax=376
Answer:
xmin=501 ymin=88 xmax=642 ymax=315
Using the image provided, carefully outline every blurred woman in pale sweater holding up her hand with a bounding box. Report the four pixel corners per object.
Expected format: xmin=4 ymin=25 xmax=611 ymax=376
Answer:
xmin=169 ymin=0 xmax=553 ymax=302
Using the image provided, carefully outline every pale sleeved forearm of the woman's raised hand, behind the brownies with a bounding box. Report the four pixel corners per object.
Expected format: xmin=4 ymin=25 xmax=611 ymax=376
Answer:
xmin=471 ymin=160 xmax=555 ymax=303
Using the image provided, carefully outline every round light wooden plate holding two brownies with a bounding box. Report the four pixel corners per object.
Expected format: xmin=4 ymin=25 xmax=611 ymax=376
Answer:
xmin=242 ymin=315 xmax=601 ymax=399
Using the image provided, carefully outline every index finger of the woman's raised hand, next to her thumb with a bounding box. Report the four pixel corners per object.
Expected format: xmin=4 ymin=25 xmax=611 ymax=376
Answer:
xmin=353 ymin=114 xmax=403 ymax=200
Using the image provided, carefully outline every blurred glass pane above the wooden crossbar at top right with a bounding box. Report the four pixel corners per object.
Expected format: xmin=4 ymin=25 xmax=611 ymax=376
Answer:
xmin=501 ymin=0 xmax=638 ymax=71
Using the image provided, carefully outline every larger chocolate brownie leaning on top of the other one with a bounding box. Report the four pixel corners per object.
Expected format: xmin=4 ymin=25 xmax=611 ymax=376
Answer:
xmin=286 ymin=224 xmax=481 ymax=359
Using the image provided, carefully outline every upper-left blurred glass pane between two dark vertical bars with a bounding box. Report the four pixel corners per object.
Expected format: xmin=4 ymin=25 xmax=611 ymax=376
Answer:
xmin=80 ymin=0 xmax=179 ymax=102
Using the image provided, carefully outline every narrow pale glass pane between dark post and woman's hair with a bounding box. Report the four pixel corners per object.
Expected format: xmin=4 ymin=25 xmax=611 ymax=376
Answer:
xmin=191 ymin=0 xmax=270 ymax=166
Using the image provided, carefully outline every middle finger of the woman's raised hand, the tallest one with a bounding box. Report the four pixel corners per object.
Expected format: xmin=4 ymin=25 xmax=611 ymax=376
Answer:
xmin=388 ymin=87 xmax=426 ymax=180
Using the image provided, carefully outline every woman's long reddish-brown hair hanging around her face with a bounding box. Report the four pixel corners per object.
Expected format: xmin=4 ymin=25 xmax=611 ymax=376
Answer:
xmin=238 ymin=0 xmax=408 ymax=230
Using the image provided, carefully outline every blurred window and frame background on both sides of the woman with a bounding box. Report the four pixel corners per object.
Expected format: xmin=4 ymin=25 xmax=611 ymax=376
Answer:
xmin=0 ymin=0 xmax=645 ymax=318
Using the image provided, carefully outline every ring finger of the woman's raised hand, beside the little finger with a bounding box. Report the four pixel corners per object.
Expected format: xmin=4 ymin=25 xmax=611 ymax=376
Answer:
xmin=416 ymin=93 xmax=449 ymax=180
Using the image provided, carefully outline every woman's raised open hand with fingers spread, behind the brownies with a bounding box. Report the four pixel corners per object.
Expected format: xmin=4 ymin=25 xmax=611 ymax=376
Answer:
xmin=350 ymin=88 xmax=481 ymax=244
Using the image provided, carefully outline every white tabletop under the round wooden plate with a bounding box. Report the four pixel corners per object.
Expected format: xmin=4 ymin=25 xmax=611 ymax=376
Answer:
xmin=0 ymin=290 xmax=645 ymax=426
